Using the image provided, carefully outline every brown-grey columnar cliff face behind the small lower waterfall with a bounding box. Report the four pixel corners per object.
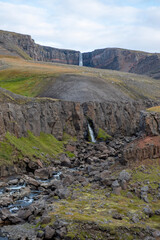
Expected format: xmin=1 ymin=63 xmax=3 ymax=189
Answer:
xmin=0 ymin=95 xmax=154 ymax=140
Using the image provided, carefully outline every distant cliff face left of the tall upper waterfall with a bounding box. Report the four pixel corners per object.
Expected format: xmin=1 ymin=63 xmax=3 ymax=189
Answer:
xmin=0 ymin=31 xmax=79 ymax=65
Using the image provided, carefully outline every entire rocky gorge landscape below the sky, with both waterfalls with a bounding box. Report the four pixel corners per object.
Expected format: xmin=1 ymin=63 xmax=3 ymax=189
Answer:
xmin=0 ymin=31 xmax=160 ymax=240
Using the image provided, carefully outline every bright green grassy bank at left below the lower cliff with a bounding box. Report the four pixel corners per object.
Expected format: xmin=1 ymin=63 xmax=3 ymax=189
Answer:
xmin=0 ymin=132 xmax=77 ymax=165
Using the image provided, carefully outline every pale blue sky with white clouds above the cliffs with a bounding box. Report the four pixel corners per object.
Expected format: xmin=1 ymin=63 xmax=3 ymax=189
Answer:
xmin=0 ymin=0 xmax=160 ymax=52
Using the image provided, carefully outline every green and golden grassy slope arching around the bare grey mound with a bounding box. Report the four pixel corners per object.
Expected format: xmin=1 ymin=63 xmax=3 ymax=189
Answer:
xmin=0 ymin=56 xmax=160 ymax=99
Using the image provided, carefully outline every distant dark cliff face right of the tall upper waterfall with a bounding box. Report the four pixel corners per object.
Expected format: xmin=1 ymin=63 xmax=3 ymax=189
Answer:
xmin=83 ymin=48 xmax=160 ymax=78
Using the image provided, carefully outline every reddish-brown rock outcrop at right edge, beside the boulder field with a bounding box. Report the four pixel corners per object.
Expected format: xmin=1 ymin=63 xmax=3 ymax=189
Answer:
xmin=123 ymin=111 xmax=160 ymax=162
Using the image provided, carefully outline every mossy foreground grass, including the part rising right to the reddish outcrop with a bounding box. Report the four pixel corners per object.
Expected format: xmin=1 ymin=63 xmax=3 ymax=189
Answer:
xmin=37 ymin=160 xmax=160 ymax=240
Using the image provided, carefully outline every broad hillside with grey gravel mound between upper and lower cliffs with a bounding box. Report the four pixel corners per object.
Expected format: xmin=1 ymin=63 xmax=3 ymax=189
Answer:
xmin=0 ymin=56 xmax=160 ymax=102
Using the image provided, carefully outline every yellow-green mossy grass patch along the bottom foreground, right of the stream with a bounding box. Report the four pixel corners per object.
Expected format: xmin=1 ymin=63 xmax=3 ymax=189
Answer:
xmin=50 ymin=182 xmax=160 ymax=239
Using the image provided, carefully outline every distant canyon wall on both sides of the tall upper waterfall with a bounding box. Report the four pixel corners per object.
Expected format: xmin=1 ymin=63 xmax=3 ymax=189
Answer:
xmin=0 ymin=30 xmax=160 ymax=79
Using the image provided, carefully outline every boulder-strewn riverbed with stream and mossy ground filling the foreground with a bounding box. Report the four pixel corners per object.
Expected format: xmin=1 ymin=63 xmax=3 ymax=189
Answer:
xmin=0 ymin=137 xmax=160 ymax=240
